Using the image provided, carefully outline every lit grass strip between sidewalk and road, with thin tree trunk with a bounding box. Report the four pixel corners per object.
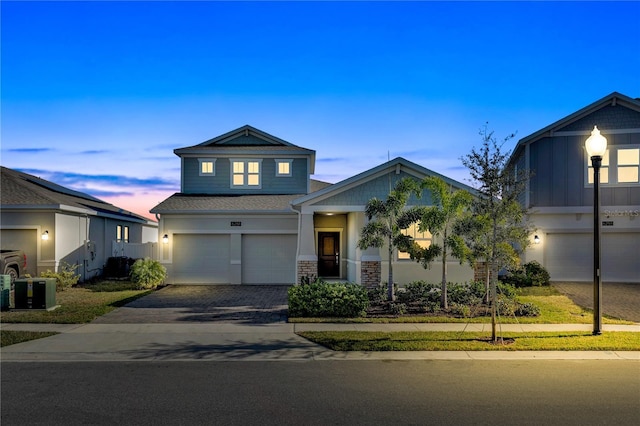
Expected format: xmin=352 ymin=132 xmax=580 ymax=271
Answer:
xmin=297 ymin=331 xmax=640 ymax=351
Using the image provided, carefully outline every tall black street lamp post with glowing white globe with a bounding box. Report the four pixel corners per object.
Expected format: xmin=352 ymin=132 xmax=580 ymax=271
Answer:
xmin=585 ymin=126 xmax=607 ymax=335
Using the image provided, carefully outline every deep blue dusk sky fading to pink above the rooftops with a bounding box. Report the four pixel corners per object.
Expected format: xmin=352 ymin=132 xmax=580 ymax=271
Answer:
xmin=0 ymin=1 xmax=640 ymax=220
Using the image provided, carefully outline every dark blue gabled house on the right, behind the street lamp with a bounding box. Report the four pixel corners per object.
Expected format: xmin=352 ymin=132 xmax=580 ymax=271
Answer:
xmin=510 ymin=92 xmax=640 ymax=283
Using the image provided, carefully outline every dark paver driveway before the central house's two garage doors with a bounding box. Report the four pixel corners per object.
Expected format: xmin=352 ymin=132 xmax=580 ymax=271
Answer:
xmin=93 ymin=285 xmax=289 ymax=325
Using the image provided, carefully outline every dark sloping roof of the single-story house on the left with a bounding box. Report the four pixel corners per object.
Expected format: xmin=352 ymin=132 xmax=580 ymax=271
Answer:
xmin=0 ymin=167 xmax=148 ymax=222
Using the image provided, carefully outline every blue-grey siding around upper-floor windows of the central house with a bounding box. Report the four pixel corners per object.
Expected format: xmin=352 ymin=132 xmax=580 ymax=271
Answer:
xmin=182 ymin=155 xmax=309 ymax=195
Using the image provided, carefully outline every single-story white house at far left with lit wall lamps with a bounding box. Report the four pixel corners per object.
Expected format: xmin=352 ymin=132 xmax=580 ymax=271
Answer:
xmin=0 ymin=167 xmax=158 ymax=281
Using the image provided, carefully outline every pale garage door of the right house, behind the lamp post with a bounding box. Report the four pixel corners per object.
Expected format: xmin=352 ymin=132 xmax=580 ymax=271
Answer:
xmin=545 ymin=232 xmax=640 ymax=282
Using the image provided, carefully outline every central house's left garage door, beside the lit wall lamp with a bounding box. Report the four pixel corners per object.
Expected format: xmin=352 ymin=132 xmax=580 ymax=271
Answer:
xmin=169 ymin=234 xmax=230 ymax=284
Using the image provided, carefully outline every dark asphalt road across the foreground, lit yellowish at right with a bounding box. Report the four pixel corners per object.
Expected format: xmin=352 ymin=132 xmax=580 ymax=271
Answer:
xmin=1 ymin=360 xmax=640 ymax=426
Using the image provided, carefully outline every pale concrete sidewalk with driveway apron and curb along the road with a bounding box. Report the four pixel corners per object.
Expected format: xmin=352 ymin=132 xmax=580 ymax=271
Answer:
xmin=1 ymin=322 xmax=640 ymax=362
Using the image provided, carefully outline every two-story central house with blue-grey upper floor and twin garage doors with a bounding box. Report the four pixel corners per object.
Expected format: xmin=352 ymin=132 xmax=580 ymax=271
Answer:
xmin=151 ymin=126 xmax=473 ymax=285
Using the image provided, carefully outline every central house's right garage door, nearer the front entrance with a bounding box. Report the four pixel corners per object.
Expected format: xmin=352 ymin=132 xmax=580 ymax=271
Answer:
xmin=242 ymin=235 xmax=297 ymax=284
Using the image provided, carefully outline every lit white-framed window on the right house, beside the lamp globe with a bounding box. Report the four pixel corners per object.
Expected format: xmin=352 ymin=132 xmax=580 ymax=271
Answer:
xmin=585 ymin=145 xmax=640 ymax=186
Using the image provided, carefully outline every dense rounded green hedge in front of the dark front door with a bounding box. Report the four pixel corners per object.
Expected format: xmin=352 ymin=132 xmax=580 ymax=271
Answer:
xmin=288 ymin=280 xmax=369 ymax=318
